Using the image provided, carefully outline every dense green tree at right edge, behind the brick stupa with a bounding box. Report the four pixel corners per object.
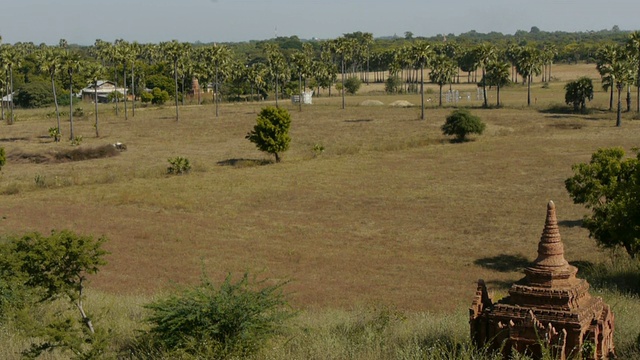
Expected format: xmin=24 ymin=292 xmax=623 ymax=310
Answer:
xmin=565 ymin=148 xmax=640 ymax=258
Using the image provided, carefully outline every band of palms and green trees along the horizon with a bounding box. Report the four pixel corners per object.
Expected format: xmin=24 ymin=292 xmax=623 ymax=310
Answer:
xmin=0 ymin=27 xmax=640 ymax=130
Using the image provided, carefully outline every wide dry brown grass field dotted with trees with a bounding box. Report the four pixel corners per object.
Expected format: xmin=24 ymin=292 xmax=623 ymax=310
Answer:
xmin=0 ymin=65 xmax=640 ymax=320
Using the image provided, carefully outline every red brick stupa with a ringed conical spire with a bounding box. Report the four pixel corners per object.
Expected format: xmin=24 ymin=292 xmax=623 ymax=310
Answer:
xmin=469 ymin=201 xmax=615 ymax=360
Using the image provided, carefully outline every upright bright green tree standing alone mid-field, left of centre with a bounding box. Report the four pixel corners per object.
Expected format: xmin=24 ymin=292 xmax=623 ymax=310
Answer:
xmin=246 ymin=106 xmax=291 ymax=163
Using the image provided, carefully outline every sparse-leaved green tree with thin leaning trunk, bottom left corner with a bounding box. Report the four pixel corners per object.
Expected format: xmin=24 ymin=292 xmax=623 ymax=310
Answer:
xmin=0 ymin=230 xmax=108 ymax=358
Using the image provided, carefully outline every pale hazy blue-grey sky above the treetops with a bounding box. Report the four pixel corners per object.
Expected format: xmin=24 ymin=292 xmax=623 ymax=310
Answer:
xmin=0 ymin=0 xmax=640 ymax=45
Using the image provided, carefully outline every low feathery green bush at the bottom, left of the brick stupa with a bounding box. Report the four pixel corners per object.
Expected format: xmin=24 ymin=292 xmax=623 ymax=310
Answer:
xmin=145 ymin=274 xmax=293 ymax=358
